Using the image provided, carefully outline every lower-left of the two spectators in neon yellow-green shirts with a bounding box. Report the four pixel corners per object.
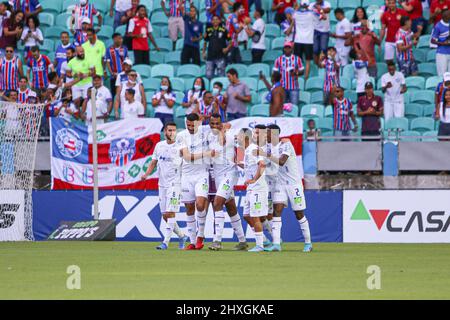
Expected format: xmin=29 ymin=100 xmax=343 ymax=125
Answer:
xmin=66 ymin=46 xmax=93 ymax=107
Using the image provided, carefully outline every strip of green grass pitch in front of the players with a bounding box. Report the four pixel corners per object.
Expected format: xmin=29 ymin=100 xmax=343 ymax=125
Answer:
xmin=0 ymin=242 xmax=450 ymax=299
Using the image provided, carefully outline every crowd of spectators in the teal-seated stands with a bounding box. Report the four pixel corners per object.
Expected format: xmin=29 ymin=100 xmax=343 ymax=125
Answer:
xmin=0 ymin=0 xmax=450 ymax=137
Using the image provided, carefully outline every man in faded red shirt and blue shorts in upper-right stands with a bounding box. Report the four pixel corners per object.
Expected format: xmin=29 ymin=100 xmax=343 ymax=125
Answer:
xmin=353 ymin=20 xmax=381 ymax=78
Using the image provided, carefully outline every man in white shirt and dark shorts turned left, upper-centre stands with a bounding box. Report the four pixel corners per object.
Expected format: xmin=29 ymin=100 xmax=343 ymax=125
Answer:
xmin=244 ymin=9 xmax=266 ymax=63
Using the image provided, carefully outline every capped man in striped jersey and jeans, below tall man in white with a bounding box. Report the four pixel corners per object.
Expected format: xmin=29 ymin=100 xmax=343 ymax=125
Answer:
xmin=273 ymin=42 xmax=305 ymax=105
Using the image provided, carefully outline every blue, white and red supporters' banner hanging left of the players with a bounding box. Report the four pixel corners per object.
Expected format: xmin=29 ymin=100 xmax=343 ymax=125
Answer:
xmin=50 ymin=118 xmax=162 ymax=190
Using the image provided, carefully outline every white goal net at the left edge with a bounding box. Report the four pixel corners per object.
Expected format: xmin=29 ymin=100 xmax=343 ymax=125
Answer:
xmin=0 ymin=102 xmax=44 ymax=241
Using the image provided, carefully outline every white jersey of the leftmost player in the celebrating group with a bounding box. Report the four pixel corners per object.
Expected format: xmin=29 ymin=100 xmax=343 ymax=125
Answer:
xmin=153 ymin=140 xmax=183 ymax=188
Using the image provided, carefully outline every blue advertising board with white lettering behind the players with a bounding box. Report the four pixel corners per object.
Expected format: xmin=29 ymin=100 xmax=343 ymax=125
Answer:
xmin=33 ymin=190 xmax=342 ymax=242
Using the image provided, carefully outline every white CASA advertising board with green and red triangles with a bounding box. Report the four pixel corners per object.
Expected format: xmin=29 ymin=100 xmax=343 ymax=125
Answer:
xmin=343 ymin=190 xmax=450 ymax=243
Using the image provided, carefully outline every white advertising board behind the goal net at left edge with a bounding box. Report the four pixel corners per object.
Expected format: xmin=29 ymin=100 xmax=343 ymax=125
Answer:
xmin=0 ymin=190 xmax=25 ymax=241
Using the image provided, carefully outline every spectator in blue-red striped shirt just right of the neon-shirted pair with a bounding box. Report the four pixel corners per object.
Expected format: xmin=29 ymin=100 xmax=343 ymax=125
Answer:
xmin=105 ymin=32 xmax=128 ymax=99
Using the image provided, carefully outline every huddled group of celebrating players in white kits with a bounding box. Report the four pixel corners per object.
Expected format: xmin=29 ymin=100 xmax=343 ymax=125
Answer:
xmin=141 ymin=113 xmax=312 ymax=252
